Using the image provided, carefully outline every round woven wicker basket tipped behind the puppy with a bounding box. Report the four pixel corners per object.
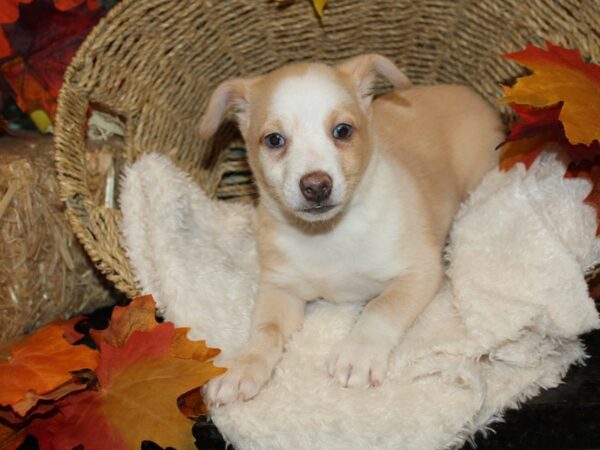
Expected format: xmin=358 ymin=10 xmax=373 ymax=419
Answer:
xmin=55 ymin=0 xmax=600 ymax=296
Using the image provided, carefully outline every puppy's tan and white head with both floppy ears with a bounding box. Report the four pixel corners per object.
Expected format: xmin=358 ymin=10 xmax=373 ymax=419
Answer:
xmin=200 ymin=54 xmax=410 ymax=222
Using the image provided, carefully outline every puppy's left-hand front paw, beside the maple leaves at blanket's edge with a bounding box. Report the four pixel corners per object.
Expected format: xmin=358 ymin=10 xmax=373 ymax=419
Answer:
xmin=204 ymin=355 xmax=272 ymax=408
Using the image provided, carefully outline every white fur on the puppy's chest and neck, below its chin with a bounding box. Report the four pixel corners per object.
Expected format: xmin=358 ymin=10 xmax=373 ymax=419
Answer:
xmin=270 ymin=153 xmax=410 ymax=302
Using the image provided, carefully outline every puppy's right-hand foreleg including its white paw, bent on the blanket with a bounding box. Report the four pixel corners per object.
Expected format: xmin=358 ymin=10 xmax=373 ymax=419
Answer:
xmin=328 ymin=258 xmax=442 ymax=387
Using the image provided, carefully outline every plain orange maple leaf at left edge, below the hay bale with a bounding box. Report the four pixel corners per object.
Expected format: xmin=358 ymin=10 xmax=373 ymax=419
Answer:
xmin=0 ymin=324 xmax=98 ymax=410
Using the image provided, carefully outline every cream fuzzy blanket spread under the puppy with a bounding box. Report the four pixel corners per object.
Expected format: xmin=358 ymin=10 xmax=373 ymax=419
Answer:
xmin=121 ymin=154 xmax=600 ymax=450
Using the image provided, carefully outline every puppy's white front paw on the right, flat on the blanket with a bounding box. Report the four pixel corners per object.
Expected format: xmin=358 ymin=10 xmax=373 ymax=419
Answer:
xmin=327 ymin=337 xmax=391 ymax=387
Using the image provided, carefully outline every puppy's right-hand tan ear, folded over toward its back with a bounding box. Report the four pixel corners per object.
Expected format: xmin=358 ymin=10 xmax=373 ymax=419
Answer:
xmin=337 ymin=53 xmax=411 ymax=106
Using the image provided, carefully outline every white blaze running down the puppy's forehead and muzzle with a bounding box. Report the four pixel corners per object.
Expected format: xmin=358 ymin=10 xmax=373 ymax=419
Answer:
xmin=260 ymin=70 xmax=352 ymax=216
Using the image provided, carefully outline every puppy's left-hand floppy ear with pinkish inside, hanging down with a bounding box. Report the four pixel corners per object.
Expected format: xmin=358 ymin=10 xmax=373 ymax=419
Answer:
xmin=198 ymin=78 xmax=255 ymax=139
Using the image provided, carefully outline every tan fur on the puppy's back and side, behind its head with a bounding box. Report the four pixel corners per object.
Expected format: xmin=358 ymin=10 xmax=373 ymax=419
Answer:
xmin=373 ymin=85 xmax=504 ymax=244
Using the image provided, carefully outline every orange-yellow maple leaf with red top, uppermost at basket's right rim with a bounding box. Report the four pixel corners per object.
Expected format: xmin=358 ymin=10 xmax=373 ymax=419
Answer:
xmin=503 ymin=42 xmax=600 ymax=145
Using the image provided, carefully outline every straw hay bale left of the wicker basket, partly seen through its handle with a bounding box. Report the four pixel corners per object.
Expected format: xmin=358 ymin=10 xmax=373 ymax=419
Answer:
xmin=0 ymin=137 xmax=113 ymax=340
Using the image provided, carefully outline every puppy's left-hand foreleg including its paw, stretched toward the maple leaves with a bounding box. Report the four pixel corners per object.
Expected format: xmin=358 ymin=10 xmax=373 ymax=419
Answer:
xmin=206 ymin=282 xmax=305 ymax=406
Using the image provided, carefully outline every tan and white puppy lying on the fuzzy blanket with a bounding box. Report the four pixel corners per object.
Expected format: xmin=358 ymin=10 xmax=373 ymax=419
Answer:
xmin=200 ymin=54 xmax=503 ymax=406
